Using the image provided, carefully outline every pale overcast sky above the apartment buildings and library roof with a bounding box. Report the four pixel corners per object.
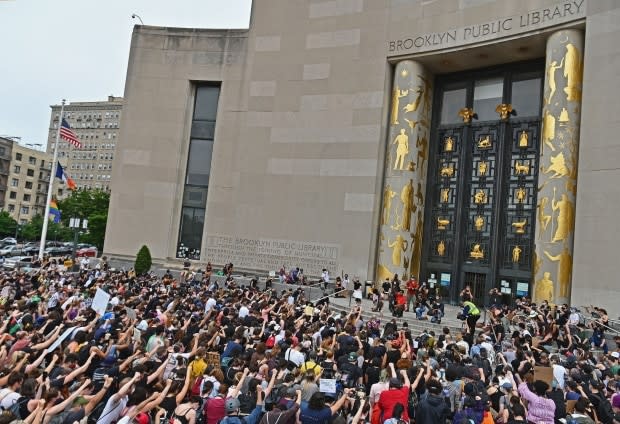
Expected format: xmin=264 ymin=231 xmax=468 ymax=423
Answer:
xmin=0 ymin=0 xmax=251 ymax=149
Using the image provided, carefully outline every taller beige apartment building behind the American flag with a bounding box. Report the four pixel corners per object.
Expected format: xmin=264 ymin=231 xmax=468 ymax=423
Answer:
xmin=47 ymin=96 xmax=123 ymax=194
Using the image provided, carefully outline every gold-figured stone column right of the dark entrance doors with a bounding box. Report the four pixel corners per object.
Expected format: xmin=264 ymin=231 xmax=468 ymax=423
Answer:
xmin=532 ymin=29 xmax=584 ymax=304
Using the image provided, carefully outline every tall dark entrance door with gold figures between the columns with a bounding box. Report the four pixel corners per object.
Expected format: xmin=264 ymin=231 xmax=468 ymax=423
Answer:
xmin=420 ymin=63 xmax=543 ymax=303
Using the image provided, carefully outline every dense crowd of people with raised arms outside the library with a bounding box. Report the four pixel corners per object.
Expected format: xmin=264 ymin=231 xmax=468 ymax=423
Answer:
xmin=0 ymin=261 xmax=620 ymax=424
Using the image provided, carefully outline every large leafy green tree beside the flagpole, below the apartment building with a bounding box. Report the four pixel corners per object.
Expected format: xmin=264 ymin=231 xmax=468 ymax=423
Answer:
xmin=57 ymin=189 xmax=110 ymax=250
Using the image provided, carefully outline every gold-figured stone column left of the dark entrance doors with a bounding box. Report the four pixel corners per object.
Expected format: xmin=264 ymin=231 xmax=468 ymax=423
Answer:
xmin=377 ymin=60 xmax=432 ymax=281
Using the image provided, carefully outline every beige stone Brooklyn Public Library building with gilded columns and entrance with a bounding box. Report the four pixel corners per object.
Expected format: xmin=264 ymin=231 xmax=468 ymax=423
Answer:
xmin=104 ymin=0 xmax=620 ymax=309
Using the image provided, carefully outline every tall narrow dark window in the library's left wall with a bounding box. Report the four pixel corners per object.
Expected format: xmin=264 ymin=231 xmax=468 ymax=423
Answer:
xmin=177 ymin=85 xmax=220 ymax=259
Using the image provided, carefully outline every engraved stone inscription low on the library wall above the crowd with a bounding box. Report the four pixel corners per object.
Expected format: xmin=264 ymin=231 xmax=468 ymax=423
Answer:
xmin=207 ymin=235 xmax=340 ymax=276
